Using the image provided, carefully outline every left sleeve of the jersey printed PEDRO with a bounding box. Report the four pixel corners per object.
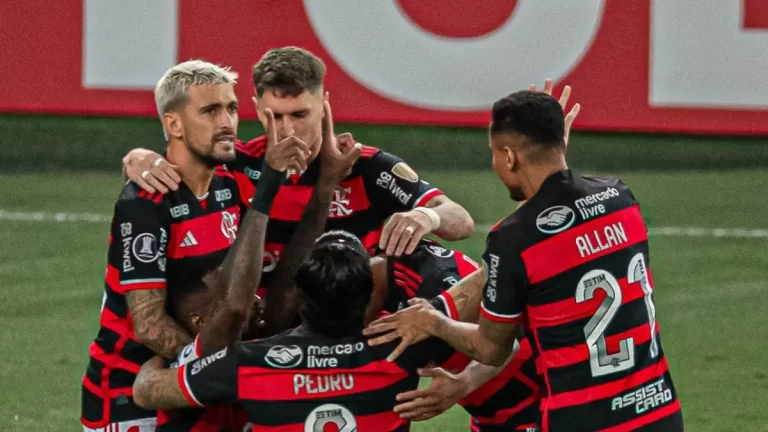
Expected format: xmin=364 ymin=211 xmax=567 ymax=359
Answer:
xmin=178 ymin=346 xmax=239 ymax=407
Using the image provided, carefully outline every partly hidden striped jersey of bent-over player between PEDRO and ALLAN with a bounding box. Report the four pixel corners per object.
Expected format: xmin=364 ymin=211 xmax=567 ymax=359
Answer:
xmin=384 ymin=239 xmax=541 ymax=432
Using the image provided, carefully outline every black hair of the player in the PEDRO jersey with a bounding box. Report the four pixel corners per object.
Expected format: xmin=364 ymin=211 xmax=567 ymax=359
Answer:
xmin=295 ymin=241 xmax=373 ymax=338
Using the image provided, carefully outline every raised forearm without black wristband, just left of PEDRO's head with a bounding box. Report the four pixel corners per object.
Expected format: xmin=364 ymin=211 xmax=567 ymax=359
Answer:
xmin=264 ymin=178 xmax=337 ymax=335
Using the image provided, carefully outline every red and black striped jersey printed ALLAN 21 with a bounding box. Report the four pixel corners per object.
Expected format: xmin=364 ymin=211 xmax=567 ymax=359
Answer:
xmin=481 ymin=170 xmax=682 ymax=431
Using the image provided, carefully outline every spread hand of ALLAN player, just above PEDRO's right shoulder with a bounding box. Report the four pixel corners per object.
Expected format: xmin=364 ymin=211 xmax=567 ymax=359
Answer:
xmin=363 ymin=298 xmax=442 ymax=361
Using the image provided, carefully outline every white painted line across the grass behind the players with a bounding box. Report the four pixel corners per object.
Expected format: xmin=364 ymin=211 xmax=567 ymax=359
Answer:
xmin=0 ymin=209 xmax=768 ymax=238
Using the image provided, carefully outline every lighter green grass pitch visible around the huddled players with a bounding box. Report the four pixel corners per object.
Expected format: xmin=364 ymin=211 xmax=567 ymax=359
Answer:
xmin=0 ymin=170 xmax=768 ymax=432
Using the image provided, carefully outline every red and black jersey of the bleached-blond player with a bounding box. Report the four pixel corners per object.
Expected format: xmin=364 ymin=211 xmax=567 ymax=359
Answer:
xmin=82 ymin=169 xmax=241 ymax=428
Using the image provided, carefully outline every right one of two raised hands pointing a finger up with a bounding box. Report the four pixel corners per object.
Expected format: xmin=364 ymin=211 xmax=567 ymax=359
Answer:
xmin=320 ymin=101 xmax=362 ymax=185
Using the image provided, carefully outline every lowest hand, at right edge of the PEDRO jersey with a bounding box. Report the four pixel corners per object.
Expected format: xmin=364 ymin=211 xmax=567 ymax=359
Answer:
xmin=395 ymin=368 xmax=467 ymax=421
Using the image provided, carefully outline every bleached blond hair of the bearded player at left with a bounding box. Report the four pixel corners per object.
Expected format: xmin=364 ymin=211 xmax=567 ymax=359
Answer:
xmin=155 ymin=60 xmax=238 ymax=120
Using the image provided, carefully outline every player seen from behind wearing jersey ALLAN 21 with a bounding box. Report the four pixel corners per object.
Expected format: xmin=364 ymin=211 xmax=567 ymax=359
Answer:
xmin=366 ymin=91 xmax=683 ymax=432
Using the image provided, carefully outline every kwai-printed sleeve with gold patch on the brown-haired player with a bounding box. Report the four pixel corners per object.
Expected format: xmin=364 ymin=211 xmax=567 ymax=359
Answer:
xmin=363 ymin=151 xmax=443 ymax=214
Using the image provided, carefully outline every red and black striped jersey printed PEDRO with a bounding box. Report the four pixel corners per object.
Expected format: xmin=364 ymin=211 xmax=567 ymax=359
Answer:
xmin=178 ymin=326 xmax=453 ymax=432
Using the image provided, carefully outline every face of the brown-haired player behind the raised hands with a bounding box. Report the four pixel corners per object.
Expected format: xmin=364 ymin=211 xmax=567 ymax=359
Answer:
xmin=256 ymin=89 xmax=325 ymax=159
